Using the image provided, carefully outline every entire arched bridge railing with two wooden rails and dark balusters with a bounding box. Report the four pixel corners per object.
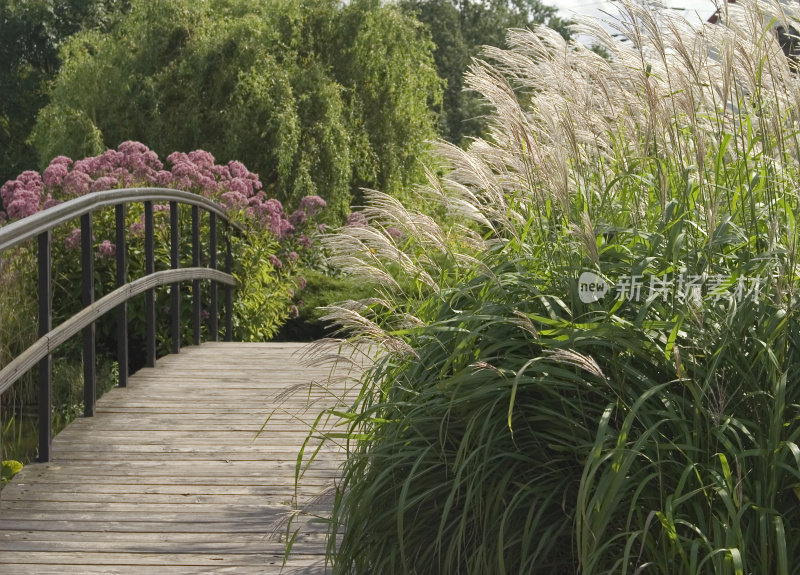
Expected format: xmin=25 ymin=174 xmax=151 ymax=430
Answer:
xmin=0 ymin=188 xmax=239 ymax=461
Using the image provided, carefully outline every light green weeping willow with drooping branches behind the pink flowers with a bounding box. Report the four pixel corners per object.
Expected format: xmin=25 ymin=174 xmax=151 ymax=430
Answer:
xmin=32 ymin=0 xmax=440 ymax=221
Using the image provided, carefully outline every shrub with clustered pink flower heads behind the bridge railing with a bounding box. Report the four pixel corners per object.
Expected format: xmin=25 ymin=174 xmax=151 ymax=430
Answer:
xmin=0 ymin=141 xmax=326 ymax=360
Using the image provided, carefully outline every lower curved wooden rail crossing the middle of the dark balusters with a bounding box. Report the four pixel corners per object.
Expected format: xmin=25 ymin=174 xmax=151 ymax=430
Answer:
xmin=0 ymin=268 xmax=237 ymax=393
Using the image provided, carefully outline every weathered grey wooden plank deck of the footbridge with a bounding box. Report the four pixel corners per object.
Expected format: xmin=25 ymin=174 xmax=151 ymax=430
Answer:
xmin=0 ymin=343 xmax=360 ymax=575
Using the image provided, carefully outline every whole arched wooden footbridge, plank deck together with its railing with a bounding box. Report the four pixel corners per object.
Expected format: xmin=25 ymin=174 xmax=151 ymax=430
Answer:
xmin=0 ymin=188 xmax=366 ymax=575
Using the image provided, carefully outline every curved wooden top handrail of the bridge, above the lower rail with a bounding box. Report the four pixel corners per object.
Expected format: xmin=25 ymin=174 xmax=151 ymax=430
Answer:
xmin=0 ymin=188 xmax=241 ymax=252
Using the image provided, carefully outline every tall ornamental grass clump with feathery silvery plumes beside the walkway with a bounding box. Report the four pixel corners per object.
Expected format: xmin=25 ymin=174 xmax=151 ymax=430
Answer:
xmin=300 ymin=1 xmax=800 ymax=575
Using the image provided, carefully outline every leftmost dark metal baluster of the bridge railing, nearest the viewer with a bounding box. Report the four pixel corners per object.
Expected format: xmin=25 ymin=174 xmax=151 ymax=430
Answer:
xmin=38 ymin=231 xmax=53 ymax=462
